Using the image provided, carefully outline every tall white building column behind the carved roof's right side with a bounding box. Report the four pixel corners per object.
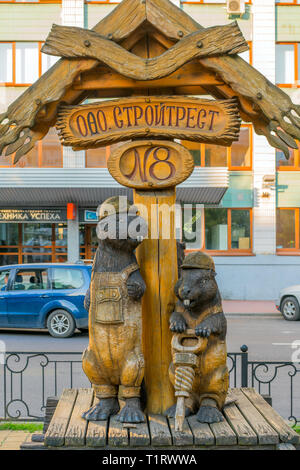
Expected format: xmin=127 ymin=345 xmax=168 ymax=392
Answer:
xmin=252 ymin=0 xmax=276 ymax=254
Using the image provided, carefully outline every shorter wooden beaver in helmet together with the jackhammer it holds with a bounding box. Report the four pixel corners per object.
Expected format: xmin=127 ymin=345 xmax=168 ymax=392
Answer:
xmin=166 ymin=251 xmax=228 ymax=425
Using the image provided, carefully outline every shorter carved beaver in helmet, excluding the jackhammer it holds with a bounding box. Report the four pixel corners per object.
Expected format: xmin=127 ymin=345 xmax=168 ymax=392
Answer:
xmin=166 ymin=251 xmax=228 ymax=423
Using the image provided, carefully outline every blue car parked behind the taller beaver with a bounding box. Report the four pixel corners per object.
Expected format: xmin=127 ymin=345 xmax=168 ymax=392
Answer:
xmin=0 ymin=263 xmax=92 ymax=338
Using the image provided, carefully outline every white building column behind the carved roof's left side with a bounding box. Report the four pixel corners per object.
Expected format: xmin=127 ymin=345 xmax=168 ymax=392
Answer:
xmin=62 ymin=0 xmax=85 ymax=168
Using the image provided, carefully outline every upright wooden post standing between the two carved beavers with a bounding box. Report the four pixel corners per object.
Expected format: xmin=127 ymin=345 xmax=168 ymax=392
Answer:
xmin=134 ymin=188 xmax=178 ymax=414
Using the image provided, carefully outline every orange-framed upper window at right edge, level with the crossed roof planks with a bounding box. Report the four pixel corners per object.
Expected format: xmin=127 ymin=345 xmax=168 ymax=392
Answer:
xmin=275 ymin=42 xmax=300 ymax=87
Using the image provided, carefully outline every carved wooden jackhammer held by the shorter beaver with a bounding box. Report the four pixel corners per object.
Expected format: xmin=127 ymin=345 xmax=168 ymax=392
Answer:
xmin=172 ymin=329 xmax=207 ymax=431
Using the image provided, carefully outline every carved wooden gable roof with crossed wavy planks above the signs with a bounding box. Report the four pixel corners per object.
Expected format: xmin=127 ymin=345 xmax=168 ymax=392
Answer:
xmin=0 ymin=0 xmax=300 ymax=162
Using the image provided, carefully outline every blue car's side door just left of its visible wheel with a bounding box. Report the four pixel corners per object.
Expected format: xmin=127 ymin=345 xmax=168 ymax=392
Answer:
xmin=7 ymin=268 xmax=50 ymax=328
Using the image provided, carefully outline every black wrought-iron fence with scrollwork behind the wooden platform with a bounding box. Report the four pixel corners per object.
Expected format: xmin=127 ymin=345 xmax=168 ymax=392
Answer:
xmin=0 ymin=346 xmax=300 ymax=424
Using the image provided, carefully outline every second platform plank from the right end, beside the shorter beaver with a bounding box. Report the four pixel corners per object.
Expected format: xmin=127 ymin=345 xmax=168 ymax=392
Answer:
xmin=230 ymin=388 xmax=279 ymax=445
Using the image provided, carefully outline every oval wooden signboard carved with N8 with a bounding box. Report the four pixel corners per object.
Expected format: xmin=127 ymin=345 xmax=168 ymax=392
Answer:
xmin=107 ymin=140 xmax=194 ymax=189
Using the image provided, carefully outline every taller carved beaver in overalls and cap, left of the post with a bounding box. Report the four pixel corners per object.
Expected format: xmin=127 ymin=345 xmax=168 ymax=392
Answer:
xmin=82 ymin=197 xmax=147 ymax=423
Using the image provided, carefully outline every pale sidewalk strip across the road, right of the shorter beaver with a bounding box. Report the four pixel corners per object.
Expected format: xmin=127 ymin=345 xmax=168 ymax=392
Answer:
xmin=222 ymin=300 xmax=281 ymax=316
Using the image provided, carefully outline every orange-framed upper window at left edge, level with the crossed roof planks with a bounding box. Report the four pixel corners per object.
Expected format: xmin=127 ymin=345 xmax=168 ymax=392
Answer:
xmin=0 ymin=42 xmax=60 ymax=86
